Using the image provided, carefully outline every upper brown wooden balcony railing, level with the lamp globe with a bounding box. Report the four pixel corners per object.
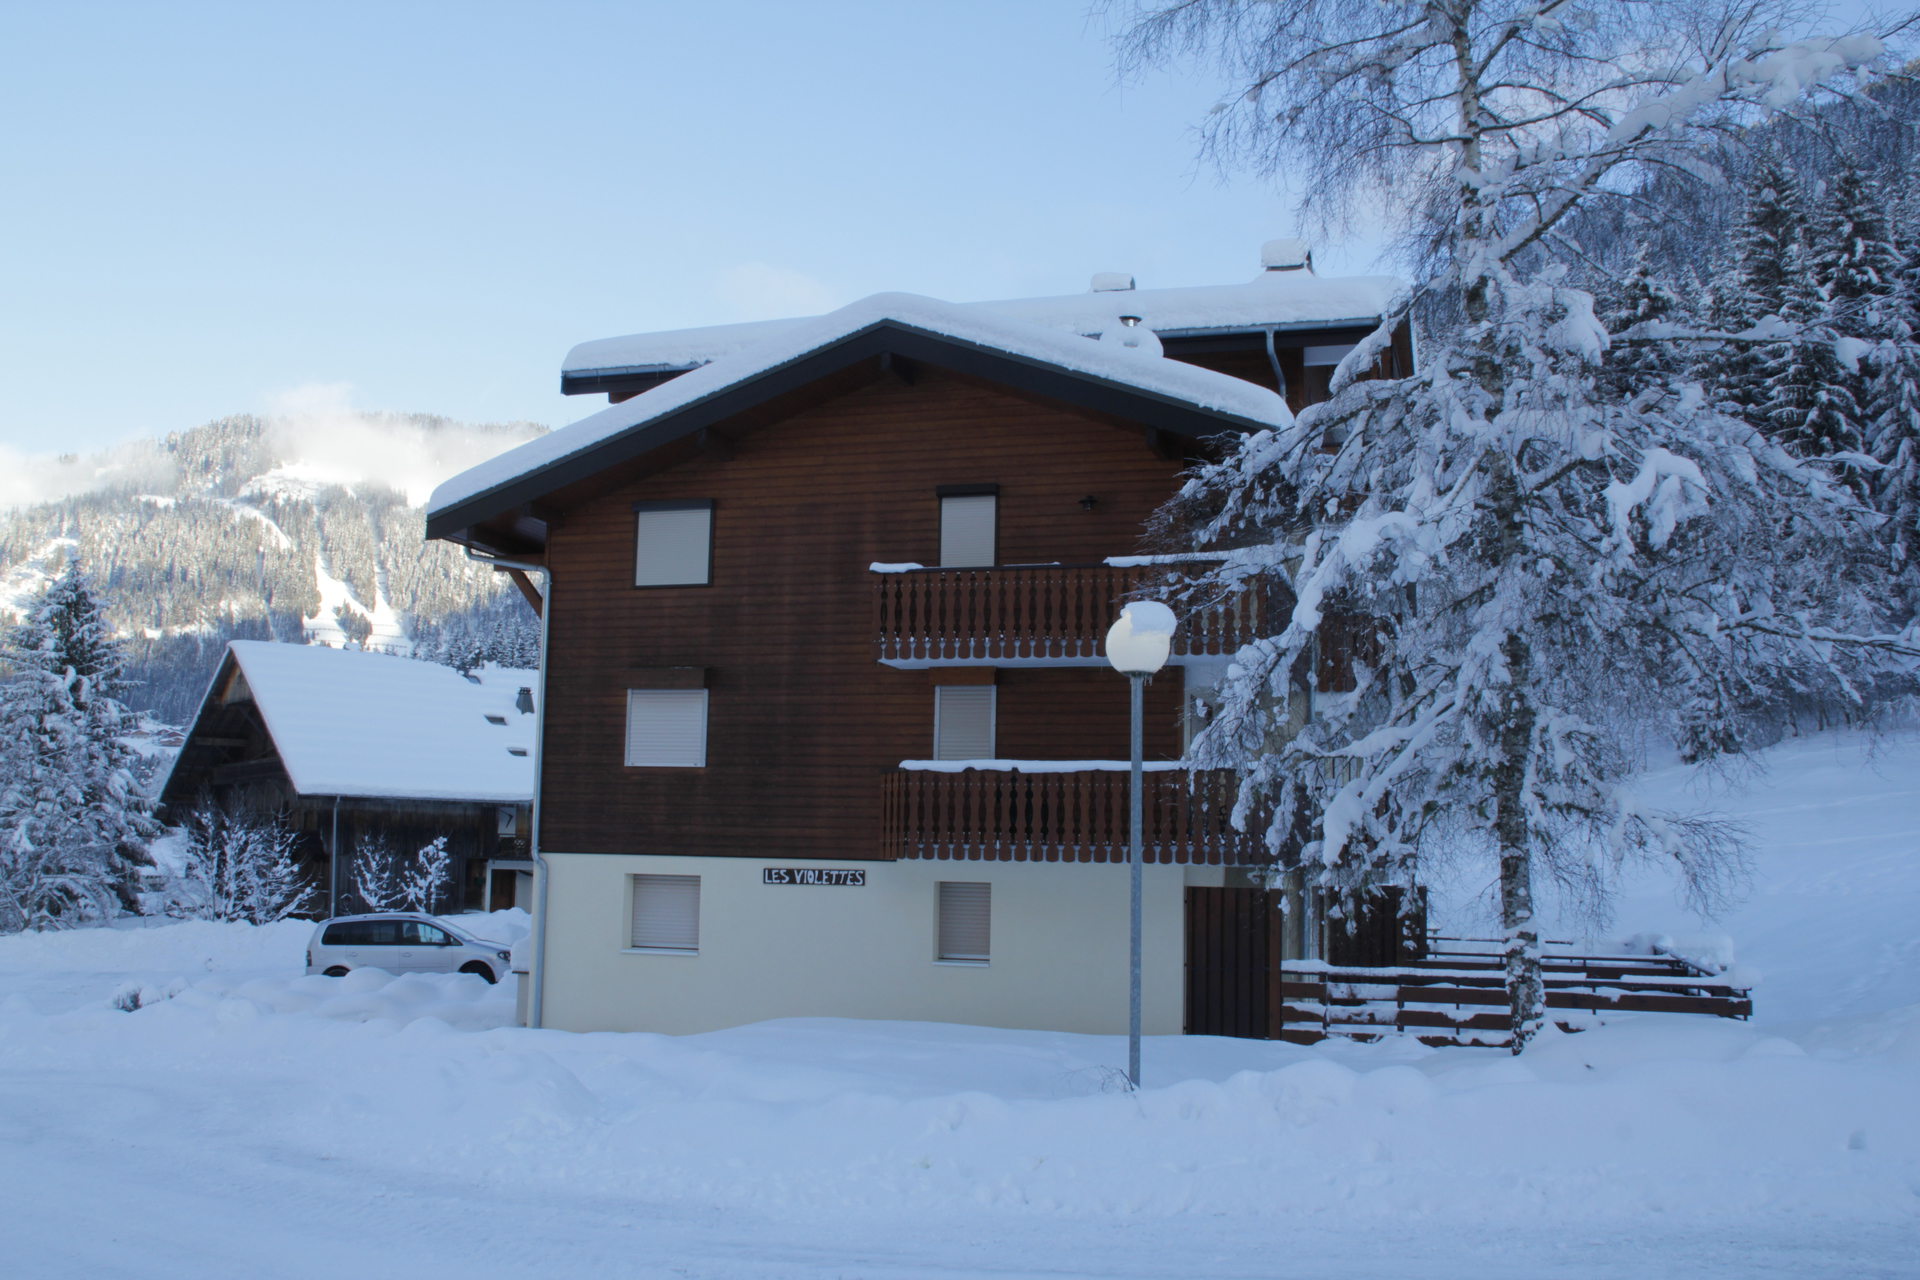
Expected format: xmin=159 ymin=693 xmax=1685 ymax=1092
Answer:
xmin=874 ymin=564 xmax=1286 ymax=662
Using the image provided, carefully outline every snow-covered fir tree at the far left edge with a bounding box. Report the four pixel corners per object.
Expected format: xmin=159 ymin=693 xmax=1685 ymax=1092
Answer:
xmin=0 ymin=560 xmax=157 ymax=929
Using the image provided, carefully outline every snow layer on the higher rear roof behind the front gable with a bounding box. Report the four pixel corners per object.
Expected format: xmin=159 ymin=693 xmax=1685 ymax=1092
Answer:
xmin=561 ymin=266 xmax=1402 ymax=374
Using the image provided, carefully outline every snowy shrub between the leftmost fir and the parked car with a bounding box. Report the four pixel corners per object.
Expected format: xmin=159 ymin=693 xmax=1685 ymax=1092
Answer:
xmin=167 ymin=804 xmax=315 ymax=925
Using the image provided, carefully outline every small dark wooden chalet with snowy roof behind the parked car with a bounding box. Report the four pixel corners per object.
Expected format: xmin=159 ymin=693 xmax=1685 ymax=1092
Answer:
xmin=161 ymin=641 xmax=538 ymax=915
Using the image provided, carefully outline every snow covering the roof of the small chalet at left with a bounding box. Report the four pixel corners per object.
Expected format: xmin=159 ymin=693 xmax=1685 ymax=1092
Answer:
xmin=216 ymin=641 xmax=540 ymax=804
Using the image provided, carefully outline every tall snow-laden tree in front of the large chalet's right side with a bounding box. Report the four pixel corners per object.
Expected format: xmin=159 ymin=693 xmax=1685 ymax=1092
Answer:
xmin=1129 ymin=0 xmax=1920 ymax=1052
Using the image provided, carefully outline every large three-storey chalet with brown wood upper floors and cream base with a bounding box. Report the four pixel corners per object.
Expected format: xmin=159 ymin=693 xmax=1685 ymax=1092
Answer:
xmin=428 ymin=242 xmax=1411 ymax=1034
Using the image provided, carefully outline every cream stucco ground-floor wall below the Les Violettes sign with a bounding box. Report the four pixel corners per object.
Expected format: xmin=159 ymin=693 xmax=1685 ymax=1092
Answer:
xmin=543 ymin=854 xmax=1221 ymax=1034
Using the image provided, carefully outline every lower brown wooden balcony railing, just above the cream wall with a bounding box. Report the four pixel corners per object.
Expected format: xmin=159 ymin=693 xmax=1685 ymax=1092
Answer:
xmin=883 ymin=762 xmax=1267 ymax=865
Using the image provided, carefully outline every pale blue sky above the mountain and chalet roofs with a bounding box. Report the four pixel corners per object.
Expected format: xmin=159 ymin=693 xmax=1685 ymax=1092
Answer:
xmin=0 ymin=0 xmax=1336 ymax=453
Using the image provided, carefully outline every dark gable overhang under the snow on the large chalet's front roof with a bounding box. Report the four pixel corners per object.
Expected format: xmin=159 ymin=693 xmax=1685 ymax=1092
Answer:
xmin=426 ymin=320 xmax=1271 ymax=555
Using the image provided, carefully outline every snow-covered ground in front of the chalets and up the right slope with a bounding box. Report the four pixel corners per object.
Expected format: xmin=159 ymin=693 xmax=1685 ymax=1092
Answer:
xmin=0 ymin=735 xmax=1920 ymax=1278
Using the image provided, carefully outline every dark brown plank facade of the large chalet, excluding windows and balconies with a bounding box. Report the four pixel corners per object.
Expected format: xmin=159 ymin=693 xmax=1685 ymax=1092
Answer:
xmin=541 ymin=367 xmax=1181 ymax=860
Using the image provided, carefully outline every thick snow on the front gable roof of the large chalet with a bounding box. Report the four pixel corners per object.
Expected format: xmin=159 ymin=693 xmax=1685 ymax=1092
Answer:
xmin=426 ymin=294 xmax=1290 ymax=516
